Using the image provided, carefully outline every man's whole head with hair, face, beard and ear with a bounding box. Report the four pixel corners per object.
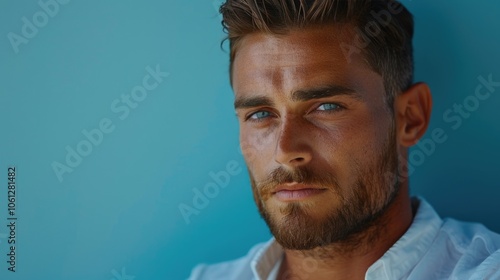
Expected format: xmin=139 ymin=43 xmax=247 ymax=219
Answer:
xmin=221 ymin=0 xmax=430 ymax=250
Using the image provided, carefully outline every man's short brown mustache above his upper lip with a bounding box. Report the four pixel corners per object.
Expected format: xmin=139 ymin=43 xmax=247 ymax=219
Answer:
xmin=257 ymin=167 xmax=339 ymax=196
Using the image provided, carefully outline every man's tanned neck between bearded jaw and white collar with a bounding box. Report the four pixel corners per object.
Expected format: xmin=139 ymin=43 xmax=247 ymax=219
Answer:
xmin=278 ymin=187 xmax=414 ymax=280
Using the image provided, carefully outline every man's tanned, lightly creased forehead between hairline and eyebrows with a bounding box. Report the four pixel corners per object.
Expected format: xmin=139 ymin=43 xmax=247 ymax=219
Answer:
xmin=232 ymin=25 xmax=380 ymax=95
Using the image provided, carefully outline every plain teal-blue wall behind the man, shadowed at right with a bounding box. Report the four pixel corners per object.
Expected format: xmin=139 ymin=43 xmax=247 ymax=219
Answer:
xmin=0 ymin=0 xmax=500 ymax=280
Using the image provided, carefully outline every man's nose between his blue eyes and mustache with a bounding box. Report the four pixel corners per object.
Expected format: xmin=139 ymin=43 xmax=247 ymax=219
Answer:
xmin=275 ymin=117 xmax=312 ymax=168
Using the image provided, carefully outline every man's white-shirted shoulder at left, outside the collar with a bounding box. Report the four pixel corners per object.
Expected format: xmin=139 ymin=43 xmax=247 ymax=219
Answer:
xmin=189 ymin=242 xmax=266 ymax=280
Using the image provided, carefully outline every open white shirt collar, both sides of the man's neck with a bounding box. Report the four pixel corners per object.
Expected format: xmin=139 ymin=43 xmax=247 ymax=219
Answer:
xmin=250 ymin=197 xmax=443 ymax=280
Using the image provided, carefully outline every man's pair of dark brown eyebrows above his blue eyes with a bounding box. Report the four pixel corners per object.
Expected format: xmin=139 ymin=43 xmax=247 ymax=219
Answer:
xmin=234 ymin=85 xmax=361 ymax=110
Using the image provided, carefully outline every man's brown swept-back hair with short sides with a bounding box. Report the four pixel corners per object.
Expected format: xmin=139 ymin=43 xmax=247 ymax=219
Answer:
xmin=220 ymin=0 xmax=413 ymax=106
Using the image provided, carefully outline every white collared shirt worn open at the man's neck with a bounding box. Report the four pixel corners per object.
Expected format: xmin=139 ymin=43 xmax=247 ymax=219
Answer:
xmin=189 ymin=198 xmax=500 ymax=280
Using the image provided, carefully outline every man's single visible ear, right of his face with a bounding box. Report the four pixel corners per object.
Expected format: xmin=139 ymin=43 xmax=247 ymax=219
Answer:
xmin=394 ymin=83 xmax=432 ymax=147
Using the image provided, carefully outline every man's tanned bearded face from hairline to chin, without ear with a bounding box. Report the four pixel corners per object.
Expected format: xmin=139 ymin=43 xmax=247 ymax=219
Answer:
xmin=232 ymin=26 xmax=399 ymax=250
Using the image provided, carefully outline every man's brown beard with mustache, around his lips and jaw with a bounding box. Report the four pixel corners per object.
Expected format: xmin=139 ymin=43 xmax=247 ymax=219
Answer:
xmin=250 ymin=123 xmax=400 ymax=250
